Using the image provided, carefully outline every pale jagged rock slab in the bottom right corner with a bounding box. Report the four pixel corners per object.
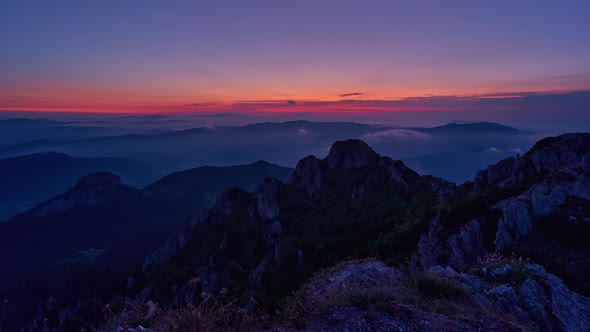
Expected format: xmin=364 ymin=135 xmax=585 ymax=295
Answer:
xmin=430 ymin=264 xmax=590 ymax=332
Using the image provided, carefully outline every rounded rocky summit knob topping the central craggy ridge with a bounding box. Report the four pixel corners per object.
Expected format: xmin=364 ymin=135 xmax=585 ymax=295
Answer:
xmin=326 ymin=139 xmax=380 ymax=169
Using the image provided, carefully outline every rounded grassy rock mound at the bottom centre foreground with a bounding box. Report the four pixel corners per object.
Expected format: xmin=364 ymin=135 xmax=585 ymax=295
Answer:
xmin=280 ymin=261 xmax=524 ymax=332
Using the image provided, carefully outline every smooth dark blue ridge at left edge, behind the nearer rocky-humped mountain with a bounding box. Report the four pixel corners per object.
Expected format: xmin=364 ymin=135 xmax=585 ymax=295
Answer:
xmin=0 ymin=152 xmax=155 ymax=222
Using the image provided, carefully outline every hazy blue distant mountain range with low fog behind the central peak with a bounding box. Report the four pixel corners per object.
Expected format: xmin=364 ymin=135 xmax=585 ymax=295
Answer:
xmin=0 ymin=121 xmax=539 ymax=182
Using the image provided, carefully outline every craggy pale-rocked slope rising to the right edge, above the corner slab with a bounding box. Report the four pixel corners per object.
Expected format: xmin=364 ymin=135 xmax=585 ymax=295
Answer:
xmin=412 ymin=134 xmax=590 ymax=279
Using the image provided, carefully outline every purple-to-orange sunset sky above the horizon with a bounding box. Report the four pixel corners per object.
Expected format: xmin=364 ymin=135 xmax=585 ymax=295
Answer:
xmin=0 ymin=0 xmax=590 ymax=112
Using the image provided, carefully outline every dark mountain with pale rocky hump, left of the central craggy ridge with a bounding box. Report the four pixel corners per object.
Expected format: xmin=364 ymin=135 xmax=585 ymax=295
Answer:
xmin=0 ymin=162 xmax=293 ymax=288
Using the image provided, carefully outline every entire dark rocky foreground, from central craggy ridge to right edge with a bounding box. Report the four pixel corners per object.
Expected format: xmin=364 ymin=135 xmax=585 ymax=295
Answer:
xmin=16 ymin=134 xmax=590 ymax=331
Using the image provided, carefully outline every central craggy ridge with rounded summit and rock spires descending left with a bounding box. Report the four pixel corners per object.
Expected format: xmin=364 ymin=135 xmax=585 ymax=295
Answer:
xmin=136 ymin=140 xmax=453 ymax=308
